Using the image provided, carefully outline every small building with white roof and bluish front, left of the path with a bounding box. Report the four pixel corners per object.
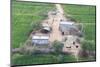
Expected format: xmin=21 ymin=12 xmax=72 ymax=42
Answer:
xmin=32 ymin=35 xmax=49 ymax=45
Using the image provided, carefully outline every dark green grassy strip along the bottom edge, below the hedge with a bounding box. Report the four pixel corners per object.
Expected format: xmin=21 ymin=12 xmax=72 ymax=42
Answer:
xmin=12 ymin=54 xmax=76 ymax=65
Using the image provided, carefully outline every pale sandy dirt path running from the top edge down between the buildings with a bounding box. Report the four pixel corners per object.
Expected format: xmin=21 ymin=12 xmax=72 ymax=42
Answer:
xmin=49 ymin=4 xmax=66 ymax=42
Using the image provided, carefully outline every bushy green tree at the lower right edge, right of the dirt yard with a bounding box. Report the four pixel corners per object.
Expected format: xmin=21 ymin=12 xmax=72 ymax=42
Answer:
xmin=81 ymin=40 xmax=96 ymax=57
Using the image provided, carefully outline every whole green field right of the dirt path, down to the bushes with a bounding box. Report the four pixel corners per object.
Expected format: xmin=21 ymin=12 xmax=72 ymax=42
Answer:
xmin=63 ymin=5 xmax=96 ymax=40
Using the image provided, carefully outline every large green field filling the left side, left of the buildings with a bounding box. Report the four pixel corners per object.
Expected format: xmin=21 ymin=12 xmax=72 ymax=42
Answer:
xmin=12 ymin=0 xmax=54 ymax=48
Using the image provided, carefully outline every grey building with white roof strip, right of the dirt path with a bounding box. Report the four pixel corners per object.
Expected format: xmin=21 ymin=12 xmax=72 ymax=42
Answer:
xmin=59 ymin=21 xmax=78 ymax=35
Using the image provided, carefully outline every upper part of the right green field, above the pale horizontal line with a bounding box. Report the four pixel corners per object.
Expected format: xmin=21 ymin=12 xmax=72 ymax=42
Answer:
xmin=63 ymin=5 xmax=96 ymax=23
